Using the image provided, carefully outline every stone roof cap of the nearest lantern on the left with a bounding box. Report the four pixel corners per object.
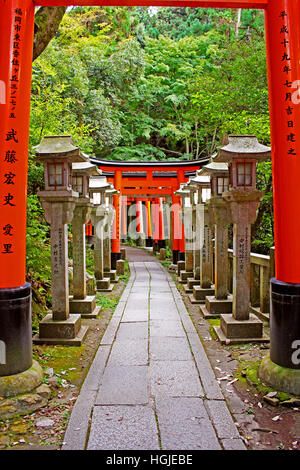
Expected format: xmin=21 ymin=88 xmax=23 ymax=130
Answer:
xmin=34 ymin=135 xmax=89 ymax=162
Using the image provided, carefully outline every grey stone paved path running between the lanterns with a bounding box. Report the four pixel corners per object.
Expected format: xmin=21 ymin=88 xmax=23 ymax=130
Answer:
xmin=63 ymin=249 xmax=245 ymax=450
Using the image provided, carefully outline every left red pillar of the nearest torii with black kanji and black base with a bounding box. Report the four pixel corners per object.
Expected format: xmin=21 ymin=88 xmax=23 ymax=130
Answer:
xmin=0 ymin=0 xmax=34 ymax=376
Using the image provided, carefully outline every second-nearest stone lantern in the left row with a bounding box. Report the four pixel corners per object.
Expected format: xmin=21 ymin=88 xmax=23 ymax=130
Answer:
xmin=70 ymin=162 xmax=101 ymax=318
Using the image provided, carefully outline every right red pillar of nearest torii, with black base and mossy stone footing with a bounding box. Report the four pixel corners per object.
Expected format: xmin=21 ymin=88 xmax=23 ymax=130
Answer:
xmin=261 ymin=0 xmax=300 ymax=395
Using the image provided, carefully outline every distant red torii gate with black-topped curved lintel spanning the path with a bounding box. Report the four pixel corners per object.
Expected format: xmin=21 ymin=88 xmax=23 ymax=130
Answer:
xmin=91 ymin=158 xmax=208 ymax=269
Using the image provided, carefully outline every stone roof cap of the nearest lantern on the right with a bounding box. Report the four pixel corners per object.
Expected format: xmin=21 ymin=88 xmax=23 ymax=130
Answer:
xmin=214 ymin=135 xmax=271 ymax=162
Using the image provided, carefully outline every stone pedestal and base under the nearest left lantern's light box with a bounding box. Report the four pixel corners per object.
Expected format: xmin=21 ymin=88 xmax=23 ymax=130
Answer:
xmin=33 ymin=196 xmax=88 ymax=346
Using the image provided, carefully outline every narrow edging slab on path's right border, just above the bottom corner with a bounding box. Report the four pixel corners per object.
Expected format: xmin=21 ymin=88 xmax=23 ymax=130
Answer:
xmin=205 ymin=400 xmax=240 ymax=439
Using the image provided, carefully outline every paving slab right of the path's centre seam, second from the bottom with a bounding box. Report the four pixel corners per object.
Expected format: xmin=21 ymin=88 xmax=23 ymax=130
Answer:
xmin=150 ymin=361 xmax=204 ymax=397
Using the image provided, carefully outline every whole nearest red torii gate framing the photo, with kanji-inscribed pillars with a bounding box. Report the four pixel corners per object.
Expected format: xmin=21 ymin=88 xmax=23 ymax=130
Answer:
xmin=0 ymin=0 xmax=300 ymax=390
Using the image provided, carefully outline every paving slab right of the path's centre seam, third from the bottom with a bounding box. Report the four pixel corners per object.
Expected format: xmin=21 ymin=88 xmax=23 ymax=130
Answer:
xmin=150 ymin=337 xmax=192 ymax=361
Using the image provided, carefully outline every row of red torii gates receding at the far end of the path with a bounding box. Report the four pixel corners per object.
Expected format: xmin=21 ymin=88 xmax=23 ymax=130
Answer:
xmin=86 ymin=157 xmax=209 ymax=269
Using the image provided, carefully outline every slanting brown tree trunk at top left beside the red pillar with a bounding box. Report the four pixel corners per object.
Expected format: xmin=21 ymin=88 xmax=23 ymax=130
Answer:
xmin=32 ymin=7 xmax=67 ymax=61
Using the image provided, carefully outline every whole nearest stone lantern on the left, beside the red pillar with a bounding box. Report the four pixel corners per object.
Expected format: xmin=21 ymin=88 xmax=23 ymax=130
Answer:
xmin=34 ymin=136 xmax=88 ymax=346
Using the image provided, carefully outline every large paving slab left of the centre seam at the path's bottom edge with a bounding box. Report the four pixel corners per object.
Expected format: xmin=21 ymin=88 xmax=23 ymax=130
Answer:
xmin=87 ymin=406 xmax=159 ymax=450
